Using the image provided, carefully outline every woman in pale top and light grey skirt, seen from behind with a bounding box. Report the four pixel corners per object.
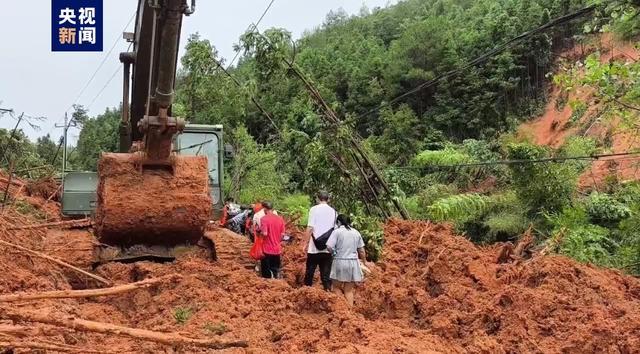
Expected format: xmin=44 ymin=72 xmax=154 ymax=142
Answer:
xmin=327 ymin=214 xmax=367 ymax=307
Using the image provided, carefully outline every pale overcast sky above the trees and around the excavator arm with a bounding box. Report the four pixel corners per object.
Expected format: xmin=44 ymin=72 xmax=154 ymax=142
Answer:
xmin=0 ymin=0 xmax=397 ymax=141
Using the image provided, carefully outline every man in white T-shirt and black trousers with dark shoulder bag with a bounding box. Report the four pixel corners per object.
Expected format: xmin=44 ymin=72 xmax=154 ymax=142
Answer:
xmin=303 ymin=192 xmax=337 ymax=290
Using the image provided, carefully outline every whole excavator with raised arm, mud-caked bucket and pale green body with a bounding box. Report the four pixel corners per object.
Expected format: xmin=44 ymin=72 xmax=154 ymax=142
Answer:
xmin=62 ymin=0 xmax=225 ymax=262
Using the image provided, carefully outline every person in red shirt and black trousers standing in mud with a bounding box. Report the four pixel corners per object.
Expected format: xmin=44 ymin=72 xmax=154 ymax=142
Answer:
xmin=260 ymin=201 xmax=285 ymax=279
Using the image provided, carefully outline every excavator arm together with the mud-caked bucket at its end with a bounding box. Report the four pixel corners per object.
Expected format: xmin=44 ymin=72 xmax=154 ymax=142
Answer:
xmin=95 ymin=0 xmax=211 ymax=248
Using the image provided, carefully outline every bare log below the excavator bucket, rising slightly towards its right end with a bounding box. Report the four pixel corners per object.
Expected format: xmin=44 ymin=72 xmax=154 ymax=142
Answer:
xmin=0 ymin=274 xmax=180 ymax=302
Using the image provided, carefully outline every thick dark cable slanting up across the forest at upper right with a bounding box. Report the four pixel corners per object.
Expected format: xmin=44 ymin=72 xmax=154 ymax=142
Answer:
xmin=356 ymin=5 xmax=596 ymax=119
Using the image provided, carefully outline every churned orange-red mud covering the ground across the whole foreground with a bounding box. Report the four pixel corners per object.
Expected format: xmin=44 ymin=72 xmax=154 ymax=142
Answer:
xmin=0 ymin=183 xmax=640 ymax=353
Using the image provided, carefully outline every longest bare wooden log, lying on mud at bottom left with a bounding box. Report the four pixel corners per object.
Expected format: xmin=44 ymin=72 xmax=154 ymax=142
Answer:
xmin=1 ymin=309 xmax=248 ymax=349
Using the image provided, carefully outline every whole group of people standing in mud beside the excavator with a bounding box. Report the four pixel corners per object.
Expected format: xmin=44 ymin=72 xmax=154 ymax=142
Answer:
xmin=223 ymin=192 xmax=366 ymax=306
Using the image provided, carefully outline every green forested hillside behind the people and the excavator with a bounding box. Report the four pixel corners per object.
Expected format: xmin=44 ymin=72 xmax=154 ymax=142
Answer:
xmin=1 ymin=0 xmax=640 ymax=273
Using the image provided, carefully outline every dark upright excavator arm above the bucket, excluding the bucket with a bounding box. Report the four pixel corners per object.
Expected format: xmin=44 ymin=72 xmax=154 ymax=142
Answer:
xmin=120 ymin=0 xmax=195 ymax=157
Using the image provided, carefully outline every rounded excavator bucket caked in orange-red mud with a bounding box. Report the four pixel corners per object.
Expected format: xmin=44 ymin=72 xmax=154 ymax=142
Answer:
xmin=96 ymin=153 xmax=212 ymax=247
